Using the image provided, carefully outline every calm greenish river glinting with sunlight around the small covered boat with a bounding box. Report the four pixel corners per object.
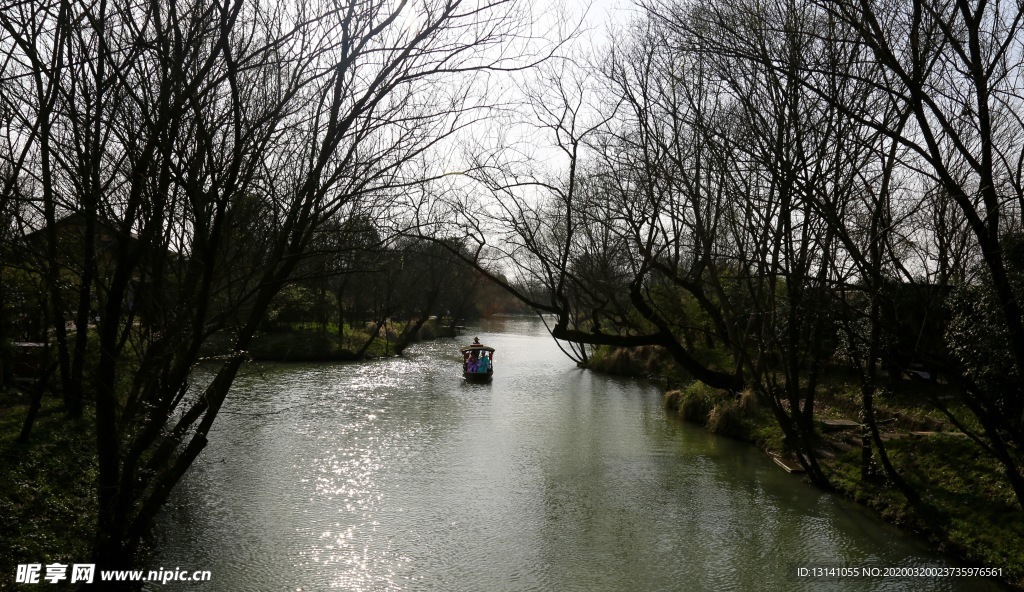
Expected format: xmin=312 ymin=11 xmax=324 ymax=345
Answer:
xmin=147 ymin=319 xmax=996 ymax=592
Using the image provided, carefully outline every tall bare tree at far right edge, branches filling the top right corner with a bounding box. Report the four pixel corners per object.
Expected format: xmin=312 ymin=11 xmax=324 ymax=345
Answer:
xmin=819 ymin=1 xmax=1024 ymax=505
